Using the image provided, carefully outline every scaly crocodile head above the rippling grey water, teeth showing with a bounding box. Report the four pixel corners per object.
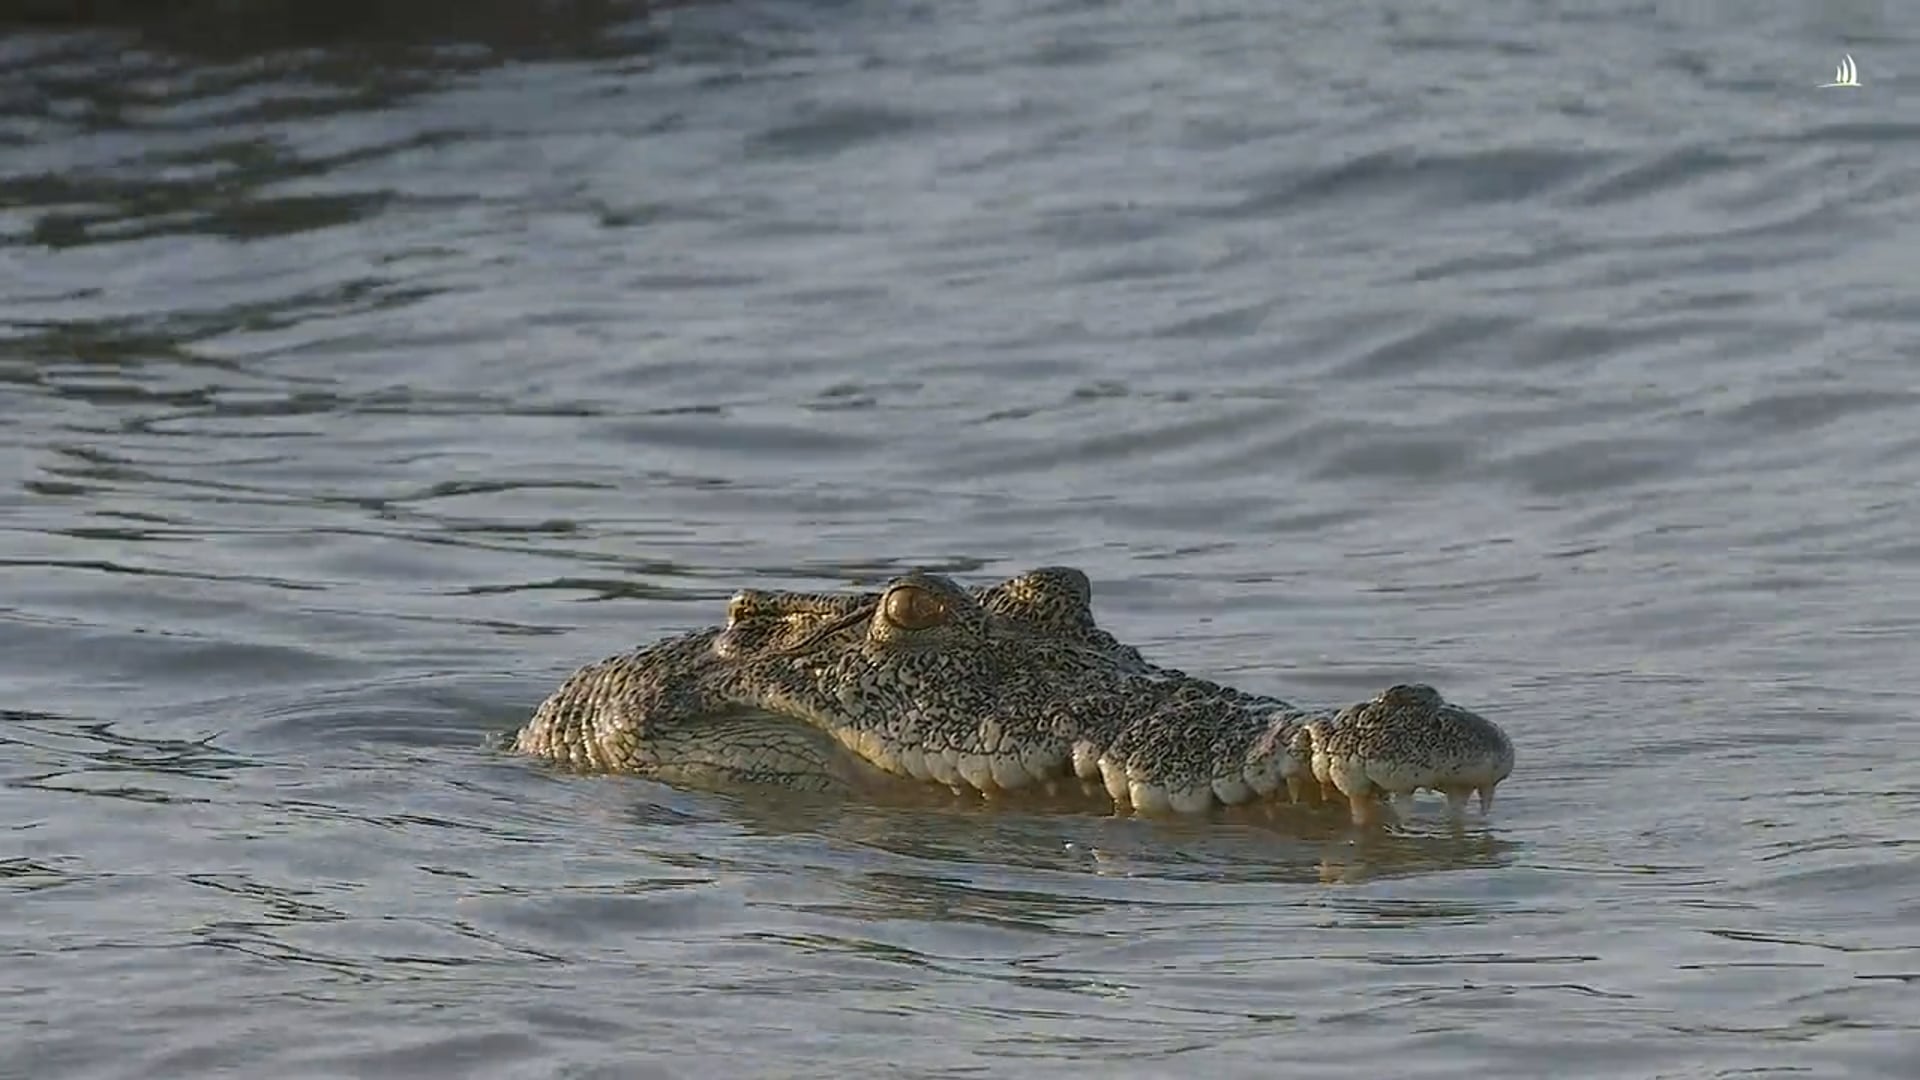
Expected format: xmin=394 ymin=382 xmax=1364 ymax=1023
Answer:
xmin=515 ymin=567 xmax=1513 ymax=821
